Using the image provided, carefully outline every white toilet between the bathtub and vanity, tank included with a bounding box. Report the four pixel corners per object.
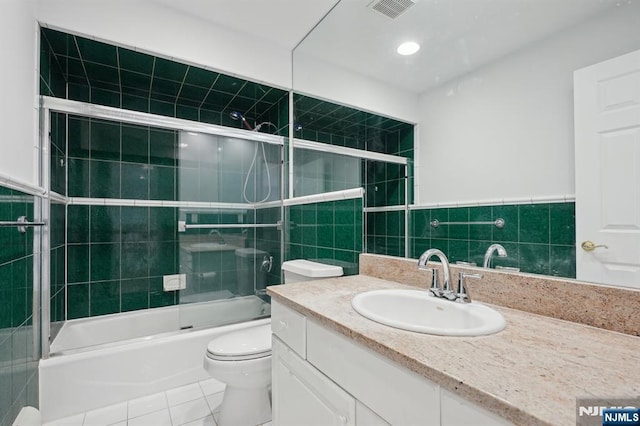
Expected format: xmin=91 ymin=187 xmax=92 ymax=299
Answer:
xmin=204 ymin=260 xmax=343 ymax=426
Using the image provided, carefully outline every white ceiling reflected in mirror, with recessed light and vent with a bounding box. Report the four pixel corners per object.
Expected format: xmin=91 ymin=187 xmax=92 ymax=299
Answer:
xmin=294 ymin=0 xmax=640 ymax=93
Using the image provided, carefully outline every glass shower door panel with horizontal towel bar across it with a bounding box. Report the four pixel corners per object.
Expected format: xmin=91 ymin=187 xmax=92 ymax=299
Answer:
xmin=176 ymin=132 xmax=282 ymax=328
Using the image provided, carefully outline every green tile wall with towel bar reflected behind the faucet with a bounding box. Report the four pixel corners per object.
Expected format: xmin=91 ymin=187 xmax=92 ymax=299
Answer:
xmin=410 ymin=203 xmax=576 ymax=278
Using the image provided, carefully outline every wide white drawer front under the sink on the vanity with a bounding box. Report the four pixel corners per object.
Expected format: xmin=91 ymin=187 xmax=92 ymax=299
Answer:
xmin=307 ymin=321 xmax=440 ymax=426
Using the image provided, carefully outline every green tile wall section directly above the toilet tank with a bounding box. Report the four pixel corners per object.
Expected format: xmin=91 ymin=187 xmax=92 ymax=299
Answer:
xmin=286 ymin=198 xmax=363 ymax=273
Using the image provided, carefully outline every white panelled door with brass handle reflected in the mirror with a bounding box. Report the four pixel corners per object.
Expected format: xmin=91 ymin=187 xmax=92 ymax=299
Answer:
xmin=574 ymin=51 xmax=640 ymax=288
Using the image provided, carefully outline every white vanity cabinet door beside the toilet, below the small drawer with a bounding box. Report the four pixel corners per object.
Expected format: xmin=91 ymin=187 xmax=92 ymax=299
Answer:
xmin=272 ymin=336 xmax=356 ymax=426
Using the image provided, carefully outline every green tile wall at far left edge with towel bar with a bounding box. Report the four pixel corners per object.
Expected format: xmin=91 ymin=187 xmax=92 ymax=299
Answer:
xmin=0 ymin=187 xmax=38 ymax=426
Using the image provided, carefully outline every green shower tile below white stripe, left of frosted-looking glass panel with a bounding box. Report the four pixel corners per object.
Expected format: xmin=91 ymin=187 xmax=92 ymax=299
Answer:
xmin=67 ymin=205 xmax=179 ymax=319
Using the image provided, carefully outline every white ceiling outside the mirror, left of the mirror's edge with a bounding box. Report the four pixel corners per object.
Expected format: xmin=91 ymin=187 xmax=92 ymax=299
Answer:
xmin=152 ymin=0 xmax=338 ymax=49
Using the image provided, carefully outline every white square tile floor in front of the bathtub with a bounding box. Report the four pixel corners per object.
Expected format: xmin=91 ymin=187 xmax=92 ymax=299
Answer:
xmin=43 ymin=379 xmax=271 ymax=426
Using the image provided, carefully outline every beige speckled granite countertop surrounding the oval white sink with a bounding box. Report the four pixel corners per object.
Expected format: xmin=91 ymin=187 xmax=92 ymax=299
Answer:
xmin=268 ymin=275 xmax=640 ymax=426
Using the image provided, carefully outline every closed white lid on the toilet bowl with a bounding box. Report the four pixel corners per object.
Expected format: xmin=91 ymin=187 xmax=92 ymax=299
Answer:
xmin=207 ymin=324 xmax=271 ymax=361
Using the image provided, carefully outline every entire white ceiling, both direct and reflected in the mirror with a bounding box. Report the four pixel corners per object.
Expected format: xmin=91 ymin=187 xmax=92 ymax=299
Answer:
xmin=146 ymin=0 xmax=640 ymax=93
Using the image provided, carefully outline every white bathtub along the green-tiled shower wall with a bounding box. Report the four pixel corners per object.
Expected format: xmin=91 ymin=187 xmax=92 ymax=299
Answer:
xmin=39 ymin=296 xmax=270 ymax=422
